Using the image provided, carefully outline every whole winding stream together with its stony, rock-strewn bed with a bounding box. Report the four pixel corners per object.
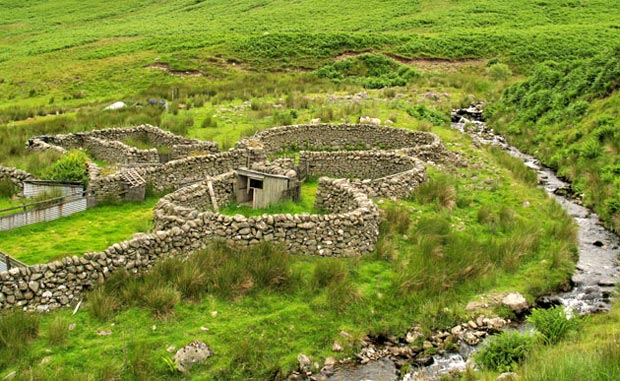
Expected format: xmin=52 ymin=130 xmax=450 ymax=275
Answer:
xmin=289 ymin=105 xmax=620 ymax=381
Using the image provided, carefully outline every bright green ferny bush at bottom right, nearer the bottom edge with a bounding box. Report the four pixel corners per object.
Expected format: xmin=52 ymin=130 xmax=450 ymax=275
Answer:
xmin=473 ymin=331 xmax=536 ymax=372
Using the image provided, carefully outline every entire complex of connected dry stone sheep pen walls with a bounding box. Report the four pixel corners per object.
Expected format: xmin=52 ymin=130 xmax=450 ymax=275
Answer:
xmin=0 ymin=124 xmax=446 ymax=311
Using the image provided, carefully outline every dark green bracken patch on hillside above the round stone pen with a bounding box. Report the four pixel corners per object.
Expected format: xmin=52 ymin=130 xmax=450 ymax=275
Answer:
xmin=316 ymin=54 xmax=419 ymax=89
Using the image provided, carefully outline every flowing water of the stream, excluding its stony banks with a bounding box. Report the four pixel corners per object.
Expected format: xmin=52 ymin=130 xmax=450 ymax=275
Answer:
xmin=329 ymin=106 xmax=620 ymax=381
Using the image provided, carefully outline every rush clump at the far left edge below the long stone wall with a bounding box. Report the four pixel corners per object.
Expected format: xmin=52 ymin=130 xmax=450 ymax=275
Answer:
xmin=0 ymin=309 xmax=39 ymax=356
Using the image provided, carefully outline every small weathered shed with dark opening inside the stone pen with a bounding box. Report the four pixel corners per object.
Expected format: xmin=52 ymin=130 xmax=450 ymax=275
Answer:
xmin=234 ymin=168 xmax=300 ymax=209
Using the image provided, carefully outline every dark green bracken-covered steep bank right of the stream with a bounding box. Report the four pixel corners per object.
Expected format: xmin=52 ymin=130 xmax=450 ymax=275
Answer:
xmin=489 ymin=47 xmax=620 ymax=231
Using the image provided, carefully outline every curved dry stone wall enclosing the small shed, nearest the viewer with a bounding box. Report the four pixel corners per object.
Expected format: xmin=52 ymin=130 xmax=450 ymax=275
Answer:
xmin=154 ymin=172 xmax=379 ymax=257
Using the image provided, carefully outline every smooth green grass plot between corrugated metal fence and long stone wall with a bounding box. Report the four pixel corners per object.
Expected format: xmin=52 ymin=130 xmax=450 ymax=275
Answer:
xmin=0 ymin=198 xmax=157 ymax=265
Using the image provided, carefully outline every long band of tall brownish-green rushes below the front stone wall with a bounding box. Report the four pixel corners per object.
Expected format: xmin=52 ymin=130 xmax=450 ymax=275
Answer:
xmin=87 ymin=242 xmax=295 ymax=320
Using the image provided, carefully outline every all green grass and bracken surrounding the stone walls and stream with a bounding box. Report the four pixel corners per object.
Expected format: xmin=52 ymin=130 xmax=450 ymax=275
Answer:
xmin=0 ymin=0 xmax=620 ymax=380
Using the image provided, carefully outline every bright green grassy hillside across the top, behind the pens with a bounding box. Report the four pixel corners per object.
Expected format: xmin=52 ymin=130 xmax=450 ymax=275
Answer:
xmin=0 ymin=0 xmax=620 ymax=110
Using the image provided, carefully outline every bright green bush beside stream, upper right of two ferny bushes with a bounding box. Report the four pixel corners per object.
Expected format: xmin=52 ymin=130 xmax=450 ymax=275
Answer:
xmin=527 ymin=306 xmax=579 ymax=344
